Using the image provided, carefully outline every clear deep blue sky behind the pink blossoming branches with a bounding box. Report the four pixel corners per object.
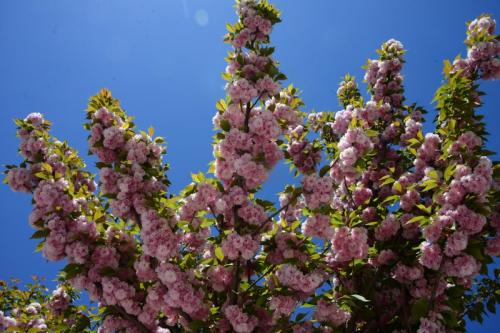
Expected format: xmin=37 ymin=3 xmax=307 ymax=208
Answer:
xmin=0 ymin=0 xmax=500 ymax=332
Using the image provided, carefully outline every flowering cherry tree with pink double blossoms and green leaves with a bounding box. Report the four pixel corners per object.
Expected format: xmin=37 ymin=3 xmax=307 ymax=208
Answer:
xmin=0 ymin=0 xmax=500 ymax=333
